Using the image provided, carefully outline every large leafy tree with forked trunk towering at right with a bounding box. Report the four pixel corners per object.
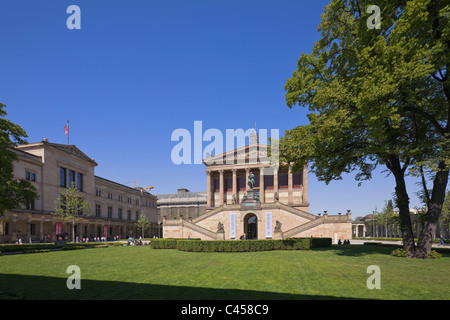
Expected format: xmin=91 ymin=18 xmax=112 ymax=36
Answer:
xmin=280 ymin=0 xmax=450 ymax=258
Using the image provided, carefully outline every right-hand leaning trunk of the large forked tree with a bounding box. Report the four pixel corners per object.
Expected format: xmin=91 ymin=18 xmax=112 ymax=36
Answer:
xmin=414 ymin=163 xmax=449 ymax=259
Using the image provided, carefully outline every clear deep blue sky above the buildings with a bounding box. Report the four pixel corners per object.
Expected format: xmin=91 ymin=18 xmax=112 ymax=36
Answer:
xmin=0 ymin=0 xmax=426 ymax=217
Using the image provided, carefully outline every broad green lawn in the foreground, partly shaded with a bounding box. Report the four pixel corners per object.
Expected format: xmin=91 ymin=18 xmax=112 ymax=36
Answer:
xmin=0 ymin=245 xmax=450 ymax=300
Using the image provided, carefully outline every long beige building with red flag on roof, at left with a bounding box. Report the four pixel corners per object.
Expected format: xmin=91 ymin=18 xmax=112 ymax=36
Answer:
xmin=0 ymin=139 xmax=161 ymax=243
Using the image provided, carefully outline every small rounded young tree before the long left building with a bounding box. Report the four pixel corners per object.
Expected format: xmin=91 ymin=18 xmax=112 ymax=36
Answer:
xmin=52 ymin=183 xmax=91 ymax=242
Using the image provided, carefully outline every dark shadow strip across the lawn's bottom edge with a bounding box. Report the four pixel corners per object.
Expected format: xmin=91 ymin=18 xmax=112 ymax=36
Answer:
xmin=0 ymin=274 xmax=364 ymax=301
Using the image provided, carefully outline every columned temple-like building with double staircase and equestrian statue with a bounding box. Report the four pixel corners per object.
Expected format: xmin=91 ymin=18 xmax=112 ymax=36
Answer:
xmin=160 ymin=135 xmax=352 ymax=242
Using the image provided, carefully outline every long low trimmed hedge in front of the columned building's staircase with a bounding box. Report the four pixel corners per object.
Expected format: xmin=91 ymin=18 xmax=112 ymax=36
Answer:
xmin=150 ymin=238 xmax=332 ymax=252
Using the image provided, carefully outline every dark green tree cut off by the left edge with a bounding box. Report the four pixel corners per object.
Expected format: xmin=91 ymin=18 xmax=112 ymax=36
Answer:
xmin=0 ymin=103 xmax=38 ymax=217
